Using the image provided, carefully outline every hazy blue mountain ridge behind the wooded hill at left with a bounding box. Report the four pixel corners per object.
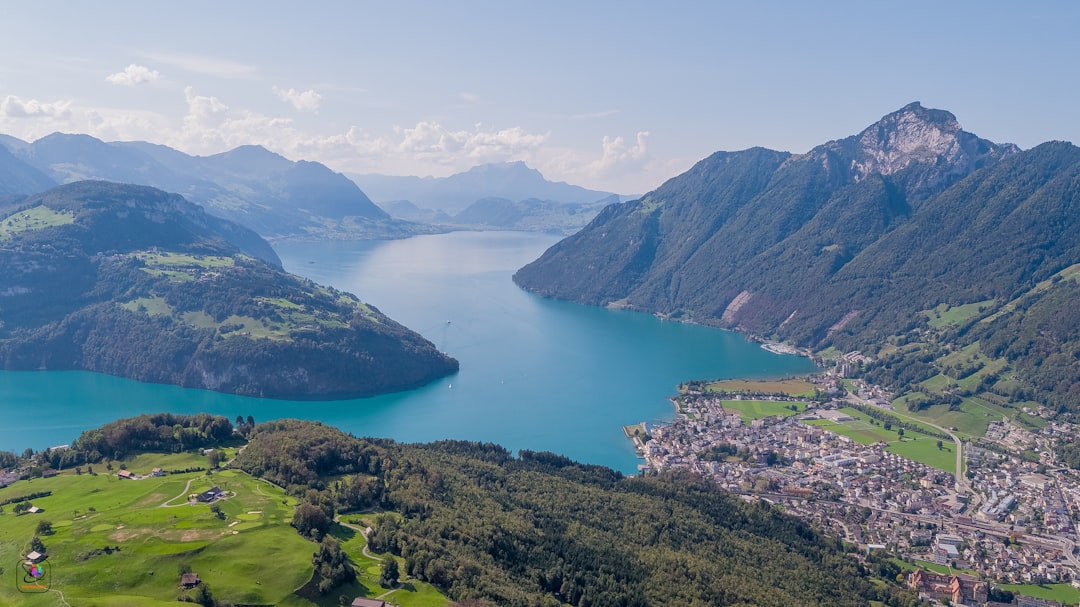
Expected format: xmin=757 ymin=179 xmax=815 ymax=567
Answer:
xmin=0 ymin=133 xmax=430 ymax=238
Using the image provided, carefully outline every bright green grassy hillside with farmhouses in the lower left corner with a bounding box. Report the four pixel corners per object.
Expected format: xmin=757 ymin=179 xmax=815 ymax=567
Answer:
xmin=0 ymin=448 xmax=447 ymax=607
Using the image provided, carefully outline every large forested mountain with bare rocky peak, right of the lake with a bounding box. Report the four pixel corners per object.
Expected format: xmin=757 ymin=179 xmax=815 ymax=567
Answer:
xmin=514 ymin=103 xmax=1080 ymax=406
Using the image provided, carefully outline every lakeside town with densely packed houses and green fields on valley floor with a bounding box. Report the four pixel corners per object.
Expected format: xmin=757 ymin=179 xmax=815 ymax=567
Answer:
xmin=625 ymin=358 xmax=1080 ymax=607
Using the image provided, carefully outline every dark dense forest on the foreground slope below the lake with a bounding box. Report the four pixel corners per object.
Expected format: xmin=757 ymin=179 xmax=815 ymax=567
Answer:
xmin=237 ymin=421 xmax=916 ymax=607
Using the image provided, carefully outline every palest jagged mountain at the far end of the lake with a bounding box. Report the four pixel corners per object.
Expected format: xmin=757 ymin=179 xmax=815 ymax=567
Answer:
xmin=349 ymin=162 xmax=626 ymax=214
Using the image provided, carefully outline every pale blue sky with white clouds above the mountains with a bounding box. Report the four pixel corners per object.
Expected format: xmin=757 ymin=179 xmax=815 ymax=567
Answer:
xmin=0 ymin=0 xmax=1080 ymax=194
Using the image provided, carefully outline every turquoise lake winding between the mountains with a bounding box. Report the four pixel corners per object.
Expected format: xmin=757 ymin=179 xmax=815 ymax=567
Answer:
xmin=0 ymin=232 xmax=814 ymax=472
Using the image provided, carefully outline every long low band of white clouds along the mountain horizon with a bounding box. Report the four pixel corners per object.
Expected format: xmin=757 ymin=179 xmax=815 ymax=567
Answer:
xmin=0 ymin=86 xmax=685 ymax=193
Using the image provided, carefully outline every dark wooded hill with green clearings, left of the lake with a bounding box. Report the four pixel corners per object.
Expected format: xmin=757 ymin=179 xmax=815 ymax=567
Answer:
xmin=0 ymin=181 xmax=458 ymax=400
